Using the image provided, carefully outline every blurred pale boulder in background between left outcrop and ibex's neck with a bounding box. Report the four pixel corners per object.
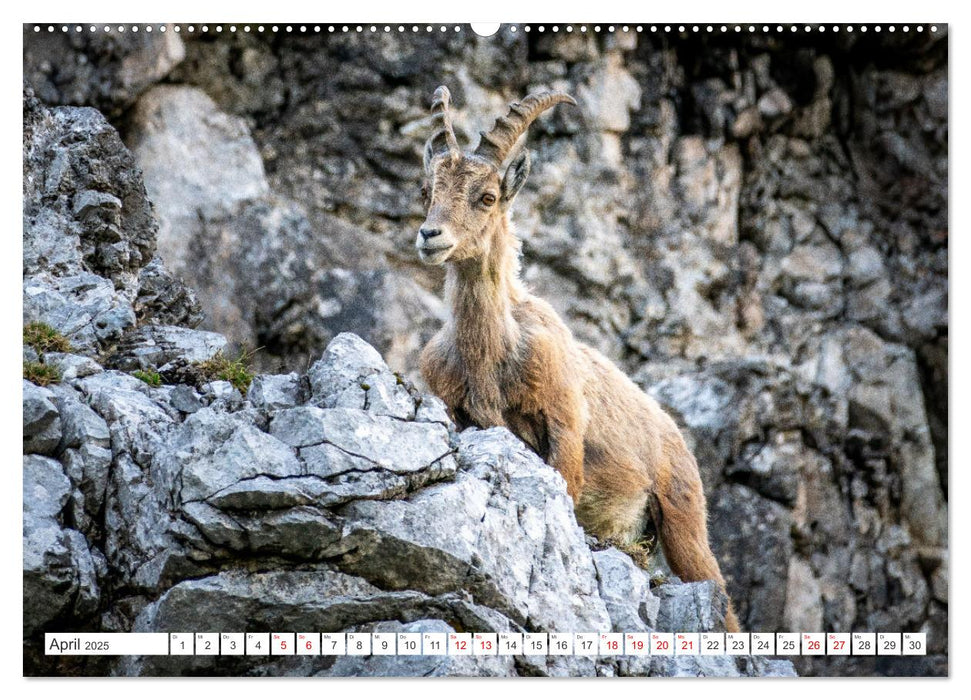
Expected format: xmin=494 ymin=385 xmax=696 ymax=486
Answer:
xmin=128 ymin=86 xmax=441 ymax=382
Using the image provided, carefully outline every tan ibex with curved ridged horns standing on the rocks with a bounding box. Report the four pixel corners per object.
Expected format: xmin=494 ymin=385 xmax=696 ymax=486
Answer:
xmin=415 ymin=86 xmax=738 ymax=631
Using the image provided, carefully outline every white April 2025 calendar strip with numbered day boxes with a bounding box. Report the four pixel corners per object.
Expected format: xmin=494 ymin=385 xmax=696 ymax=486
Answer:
xmin=44 ymin=632 xmax=927 ymax=657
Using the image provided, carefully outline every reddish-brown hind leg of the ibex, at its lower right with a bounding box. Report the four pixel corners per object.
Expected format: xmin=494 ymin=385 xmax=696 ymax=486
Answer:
xmin=652 ymin=462 xmax=739 ymax=632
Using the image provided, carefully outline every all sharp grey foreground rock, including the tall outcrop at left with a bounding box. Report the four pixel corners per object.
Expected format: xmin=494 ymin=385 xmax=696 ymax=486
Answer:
xmin=23 ymin=85 xmax=794 ymax=676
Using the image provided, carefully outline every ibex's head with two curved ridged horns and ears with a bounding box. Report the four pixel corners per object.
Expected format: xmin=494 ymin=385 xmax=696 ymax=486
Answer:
xmin=415 ymin=86 xmax=576 ymax=265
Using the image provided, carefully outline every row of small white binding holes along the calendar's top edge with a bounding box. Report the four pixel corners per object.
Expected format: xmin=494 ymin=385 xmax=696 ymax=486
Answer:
xmin=34 ymin=24 xmax=938 ymax=34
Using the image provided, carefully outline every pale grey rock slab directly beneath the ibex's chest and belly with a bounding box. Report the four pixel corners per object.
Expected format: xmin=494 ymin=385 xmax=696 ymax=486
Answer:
xmin=335 ymin=426 xmax=610 ymax=630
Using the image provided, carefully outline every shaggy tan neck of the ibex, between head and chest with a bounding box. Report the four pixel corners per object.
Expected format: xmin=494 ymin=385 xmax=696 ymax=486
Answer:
xmin=445 ymin=224 xmax=523 ymax=366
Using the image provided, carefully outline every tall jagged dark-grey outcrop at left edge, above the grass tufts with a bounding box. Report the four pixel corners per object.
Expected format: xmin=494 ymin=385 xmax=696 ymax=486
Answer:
xmin=23 ymin=87 xmax=197 ymax=354
